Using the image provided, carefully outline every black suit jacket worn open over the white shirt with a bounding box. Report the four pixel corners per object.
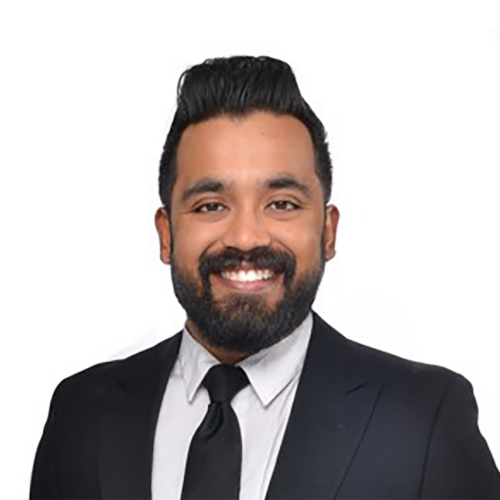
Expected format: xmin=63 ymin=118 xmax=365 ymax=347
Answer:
xmin=30 ymin=312 xmax=500 ymax=500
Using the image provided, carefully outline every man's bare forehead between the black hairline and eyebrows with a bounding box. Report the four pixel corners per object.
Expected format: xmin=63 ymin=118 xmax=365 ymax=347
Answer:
xmin=176 ymin=112 xmax=319 ymax=191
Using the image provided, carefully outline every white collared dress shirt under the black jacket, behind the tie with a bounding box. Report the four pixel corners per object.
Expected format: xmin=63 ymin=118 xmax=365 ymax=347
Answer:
xmin=152 ymin=312 xmax=312 ymax=500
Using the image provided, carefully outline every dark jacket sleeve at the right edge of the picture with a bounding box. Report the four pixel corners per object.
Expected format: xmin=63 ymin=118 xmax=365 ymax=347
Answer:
xmin=420 ymin=374 xmax=500 ymax=500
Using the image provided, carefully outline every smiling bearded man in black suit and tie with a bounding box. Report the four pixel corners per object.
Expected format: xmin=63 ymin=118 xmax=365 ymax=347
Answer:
xmin=31 ymin=57 xmax=500 ymax=500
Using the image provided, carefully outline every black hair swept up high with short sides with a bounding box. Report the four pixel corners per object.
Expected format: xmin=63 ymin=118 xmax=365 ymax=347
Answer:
xmin=159 ymin=56 xmax=332 ymax=218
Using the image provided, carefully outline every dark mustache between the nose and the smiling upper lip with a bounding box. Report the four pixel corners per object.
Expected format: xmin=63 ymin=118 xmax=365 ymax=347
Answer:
xmin=199 ymin=247 xmax=297 ymax=279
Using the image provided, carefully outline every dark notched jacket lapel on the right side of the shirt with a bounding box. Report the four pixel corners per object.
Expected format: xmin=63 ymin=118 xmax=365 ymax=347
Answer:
xmin=266 ymin=312 xmax=382 ymax=500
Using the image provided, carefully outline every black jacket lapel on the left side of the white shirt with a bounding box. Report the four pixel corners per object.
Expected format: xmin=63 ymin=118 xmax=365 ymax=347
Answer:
xmin=99 ymin=332 xmax=181 ymax=500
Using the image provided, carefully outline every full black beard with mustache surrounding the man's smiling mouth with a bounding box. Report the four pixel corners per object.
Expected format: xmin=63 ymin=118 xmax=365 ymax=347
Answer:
xmin=171 ymin=237 xmax=326 ymax=356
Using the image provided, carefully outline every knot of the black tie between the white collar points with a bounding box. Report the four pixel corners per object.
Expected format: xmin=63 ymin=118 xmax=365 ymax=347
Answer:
xmin=203 ymin=364 xmax=249 ymax=403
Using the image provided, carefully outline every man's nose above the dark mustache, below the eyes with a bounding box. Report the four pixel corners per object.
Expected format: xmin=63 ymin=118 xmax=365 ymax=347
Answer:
xmin=223 ymin=208 xmax=271 ymax=251
